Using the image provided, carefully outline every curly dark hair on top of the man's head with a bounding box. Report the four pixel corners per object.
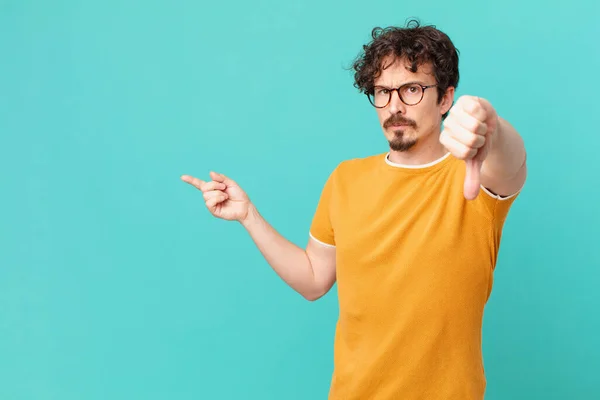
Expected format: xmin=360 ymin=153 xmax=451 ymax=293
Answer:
xmin=352 ymin=19 xmax=459 ymax=118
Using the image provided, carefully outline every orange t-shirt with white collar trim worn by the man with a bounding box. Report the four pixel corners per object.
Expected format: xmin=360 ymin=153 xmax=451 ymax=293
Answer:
xmin=310 ymin=154 xmax=516 ymax=400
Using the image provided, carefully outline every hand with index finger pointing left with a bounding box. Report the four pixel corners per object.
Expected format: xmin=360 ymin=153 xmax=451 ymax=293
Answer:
xmin=181 ymin=172 xmax=250 ymax=221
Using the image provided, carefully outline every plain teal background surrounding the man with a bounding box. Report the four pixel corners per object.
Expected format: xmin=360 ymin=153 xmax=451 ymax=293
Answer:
xmin=0 ymin=0 xmax=600 ymax=400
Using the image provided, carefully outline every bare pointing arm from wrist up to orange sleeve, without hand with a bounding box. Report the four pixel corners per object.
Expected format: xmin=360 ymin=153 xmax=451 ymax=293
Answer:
xmin=240 ymin=204 xmax=336 ymax=301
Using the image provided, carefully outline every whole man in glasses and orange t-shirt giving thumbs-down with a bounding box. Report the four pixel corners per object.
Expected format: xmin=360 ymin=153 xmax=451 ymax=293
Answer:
xmin=182 ymin=19 xmax=526 ymax=400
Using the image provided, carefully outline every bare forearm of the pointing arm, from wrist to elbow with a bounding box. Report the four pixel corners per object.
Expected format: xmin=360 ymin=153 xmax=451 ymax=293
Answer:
xmin=240 ymin=206 xmax=319 ymax=298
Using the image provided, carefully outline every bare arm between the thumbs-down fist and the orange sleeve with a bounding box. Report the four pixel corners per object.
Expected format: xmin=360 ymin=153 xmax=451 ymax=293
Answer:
xmin=481 ymin=117 xmax=527 ymax=196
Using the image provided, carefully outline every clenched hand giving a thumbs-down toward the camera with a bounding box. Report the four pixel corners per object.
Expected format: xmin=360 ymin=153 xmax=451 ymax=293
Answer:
xmin=440 ymin=96 xmax=498 ymax=200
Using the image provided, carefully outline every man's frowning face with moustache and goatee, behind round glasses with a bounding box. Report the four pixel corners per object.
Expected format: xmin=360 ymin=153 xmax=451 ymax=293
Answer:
xmin=374 ymin=58 xmax=454 ymax=151
